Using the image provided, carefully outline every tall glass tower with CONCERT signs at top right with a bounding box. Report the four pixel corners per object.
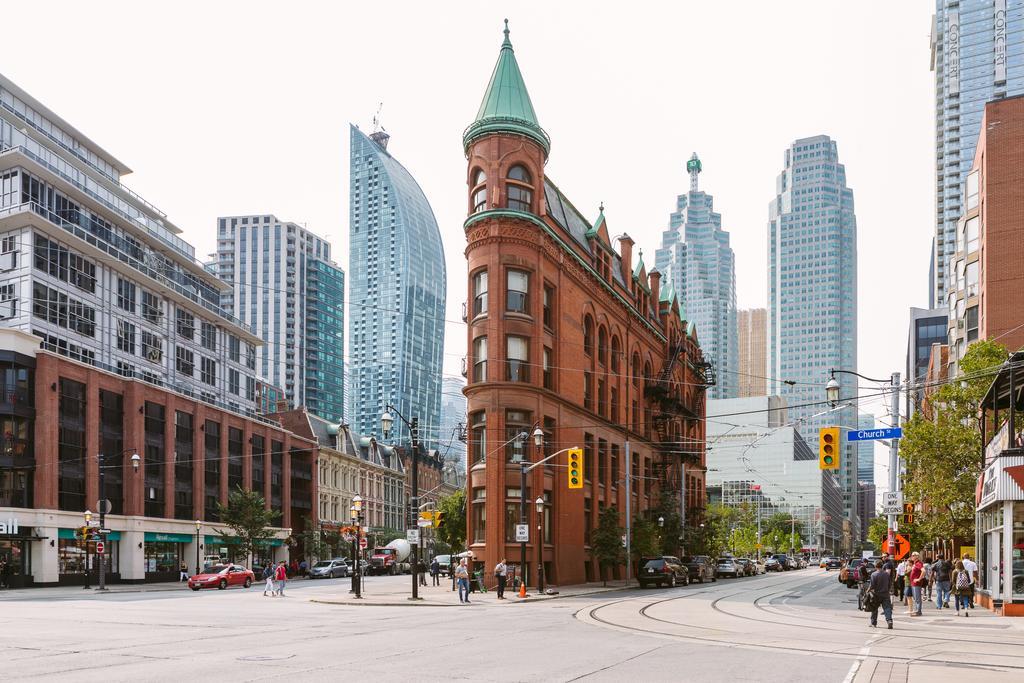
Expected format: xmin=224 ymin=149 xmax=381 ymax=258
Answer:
xmin=931 ymin=0 xmax=1024 ymax=306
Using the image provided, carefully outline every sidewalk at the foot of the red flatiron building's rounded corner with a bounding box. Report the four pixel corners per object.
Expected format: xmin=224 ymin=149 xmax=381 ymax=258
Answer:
xmin=310 ymin=580 xmax=636 ymax=607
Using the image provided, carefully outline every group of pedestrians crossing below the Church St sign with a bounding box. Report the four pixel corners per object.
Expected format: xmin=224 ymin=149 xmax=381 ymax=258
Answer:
xmin=860 ymin=552 xmax=978 ymax=629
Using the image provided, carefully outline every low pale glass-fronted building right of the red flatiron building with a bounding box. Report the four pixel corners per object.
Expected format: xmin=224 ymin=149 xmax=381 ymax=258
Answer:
xmin=708 ymin=396 xmax=844 ymax=555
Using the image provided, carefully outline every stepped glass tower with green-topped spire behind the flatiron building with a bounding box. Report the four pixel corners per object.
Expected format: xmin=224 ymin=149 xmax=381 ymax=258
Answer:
xmin=654 ymin=154 xmax=737 ymax=398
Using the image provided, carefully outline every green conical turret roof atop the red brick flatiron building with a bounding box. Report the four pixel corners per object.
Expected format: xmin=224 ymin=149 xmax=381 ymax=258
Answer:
xmin=462 ymin=19 xmax=551 ymax=154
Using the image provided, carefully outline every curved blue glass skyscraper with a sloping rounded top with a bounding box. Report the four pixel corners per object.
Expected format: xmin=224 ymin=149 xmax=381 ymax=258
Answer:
xmin=348 ymin=126 xmax=447 ymax=444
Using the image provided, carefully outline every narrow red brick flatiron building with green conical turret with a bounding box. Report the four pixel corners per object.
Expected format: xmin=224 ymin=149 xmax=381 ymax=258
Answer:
xmin=463 ymin=22 xmax=709 ymax=584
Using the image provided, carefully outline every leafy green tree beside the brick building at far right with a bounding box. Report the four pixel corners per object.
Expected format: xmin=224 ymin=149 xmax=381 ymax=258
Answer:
xmin=900 ymin=341 xmax=1007 ymax=539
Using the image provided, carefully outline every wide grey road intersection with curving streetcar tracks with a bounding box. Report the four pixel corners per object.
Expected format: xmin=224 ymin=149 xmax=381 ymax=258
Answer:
xmin=0 ymin=569 xmax=1024 ymax=683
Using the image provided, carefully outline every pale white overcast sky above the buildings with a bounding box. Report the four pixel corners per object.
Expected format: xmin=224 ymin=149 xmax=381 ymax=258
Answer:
xmin=0 ymin=0 xmax=935 ymax=489
